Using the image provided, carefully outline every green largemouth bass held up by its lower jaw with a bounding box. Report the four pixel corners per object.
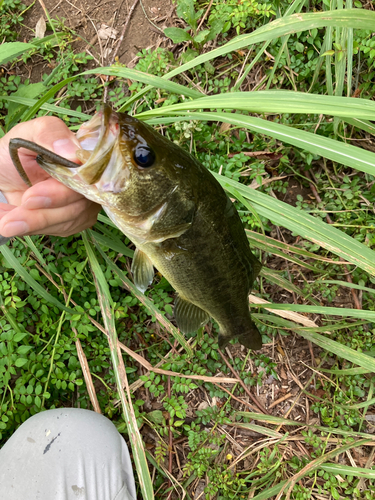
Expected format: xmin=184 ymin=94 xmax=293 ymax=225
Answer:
xmin=7 ymin=105 xmax=262 ymax=350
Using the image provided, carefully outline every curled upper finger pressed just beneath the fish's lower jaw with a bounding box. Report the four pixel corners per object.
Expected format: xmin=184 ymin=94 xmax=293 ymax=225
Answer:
xmin=22 ymin=178 xmax=83 ymax=210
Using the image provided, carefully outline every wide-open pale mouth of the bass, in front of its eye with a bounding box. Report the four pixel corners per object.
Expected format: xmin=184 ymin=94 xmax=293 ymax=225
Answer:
xmin=37 ymin=104 xmax=131 ymax=203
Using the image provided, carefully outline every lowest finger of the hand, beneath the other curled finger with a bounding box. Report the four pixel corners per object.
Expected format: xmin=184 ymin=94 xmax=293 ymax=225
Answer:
xmin=0 ymin=198 xmax=100 ymax=237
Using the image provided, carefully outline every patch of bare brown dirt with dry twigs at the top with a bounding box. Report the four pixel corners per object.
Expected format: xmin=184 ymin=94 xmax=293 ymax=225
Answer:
xmin=20 ymin=0 xmax=175 ymax=81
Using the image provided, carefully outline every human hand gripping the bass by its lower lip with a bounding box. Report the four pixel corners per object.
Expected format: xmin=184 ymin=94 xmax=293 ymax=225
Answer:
xmin=0 ymin=116 xmax=100 ymax=237
